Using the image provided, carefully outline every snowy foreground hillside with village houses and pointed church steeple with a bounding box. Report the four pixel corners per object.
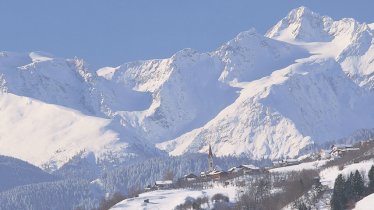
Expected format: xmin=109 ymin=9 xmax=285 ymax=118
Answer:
xmin=107 ymin=139 xmax=374 ymax=210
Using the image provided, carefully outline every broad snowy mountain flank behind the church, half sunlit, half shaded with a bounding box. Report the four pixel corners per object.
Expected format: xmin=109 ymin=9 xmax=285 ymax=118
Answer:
xmin=158 ymin=59 xmax=374 ymax=159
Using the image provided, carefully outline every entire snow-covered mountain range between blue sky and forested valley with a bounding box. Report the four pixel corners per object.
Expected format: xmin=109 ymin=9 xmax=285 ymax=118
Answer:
xmin=0 ymin=7 xmax=374 ymax=169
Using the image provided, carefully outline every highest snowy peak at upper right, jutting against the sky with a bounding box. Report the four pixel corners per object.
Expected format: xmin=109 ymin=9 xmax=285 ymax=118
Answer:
xmin=266 ymin=7 xmax=374 ymax=89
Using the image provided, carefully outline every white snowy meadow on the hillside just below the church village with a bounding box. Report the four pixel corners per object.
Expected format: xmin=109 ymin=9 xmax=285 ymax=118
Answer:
xmin=111 ymin=186 xmax=236 ymax=210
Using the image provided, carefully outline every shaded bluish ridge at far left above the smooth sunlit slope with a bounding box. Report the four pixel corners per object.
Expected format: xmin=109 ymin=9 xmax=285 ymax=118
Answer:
xmin=0 ymin=52 xmax=100 ymax=115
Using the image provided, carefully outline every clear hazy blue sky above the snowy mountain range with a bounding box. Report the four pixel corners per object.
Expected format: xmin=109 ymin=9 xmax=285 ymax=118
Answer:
xmin=0 ymin=0 xmax=374 ymax=69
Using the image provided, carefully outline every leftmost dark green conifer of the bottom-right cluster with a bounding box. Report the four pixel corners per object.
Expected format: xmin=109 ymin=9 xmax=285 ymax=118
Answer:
xmin=330 ymin=174 xmax=347 ymax=210
